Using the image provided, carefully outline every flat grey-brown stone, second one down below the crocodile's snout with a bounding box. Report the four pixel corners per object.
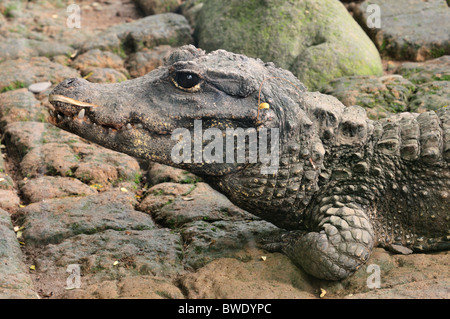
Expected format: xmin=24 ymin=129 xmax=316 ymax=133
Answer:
xmin=17 ymin=190 xmax=155 ymax=247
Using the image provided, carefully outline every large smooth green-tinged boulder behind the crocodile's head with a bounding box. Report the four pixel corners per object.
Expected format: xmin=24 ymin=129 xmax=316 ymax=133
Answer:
xmin=195 ymin=0 xmax=382 ymax=89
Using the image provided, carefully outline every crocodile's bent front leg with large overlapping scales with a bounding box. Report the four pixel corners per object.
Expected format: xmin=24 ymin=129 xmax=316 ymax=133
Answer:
xmin=282 ymin=204 xmax=375 ymax=280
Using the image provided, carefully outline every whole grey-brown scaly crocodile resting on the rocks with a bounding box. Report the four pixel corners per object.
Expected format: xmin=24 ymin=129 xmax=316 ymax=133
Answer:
xmin=48 ymin=45 xmax=450 ymax=280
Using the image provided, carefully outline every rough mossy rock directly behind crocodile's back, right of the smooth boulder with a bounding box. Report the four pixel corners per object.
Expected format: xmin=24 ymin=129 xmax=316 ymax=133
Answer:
xmin=321 ymin=55 xmax=450 ymax=119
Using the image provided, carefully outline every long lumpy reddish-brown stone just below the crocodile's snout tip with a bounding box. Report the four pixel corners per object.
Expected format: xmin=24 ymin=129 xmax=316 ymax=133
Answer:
xmin=5 ymin=122 xmax=141 ymax=189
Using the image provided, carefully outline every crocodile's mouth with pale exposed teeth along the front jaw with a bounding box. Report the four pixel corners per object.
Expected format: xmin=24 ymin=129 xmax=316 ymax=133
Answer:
xmin=47 ymin=94 xmax=171 ymax=135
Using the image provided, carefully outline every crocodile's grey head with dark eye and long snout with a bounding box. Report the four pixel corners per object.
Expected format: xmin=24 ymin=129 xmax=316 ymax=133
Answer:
xmin=49 ymin=46 xmax=310 ymax=175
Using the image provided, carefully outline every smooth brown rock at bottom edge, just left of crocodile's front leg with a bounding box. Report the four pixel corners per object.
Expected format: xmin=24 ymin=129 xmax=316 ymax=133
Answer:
xmin=180 ymin=249 xmax=316 ymax=299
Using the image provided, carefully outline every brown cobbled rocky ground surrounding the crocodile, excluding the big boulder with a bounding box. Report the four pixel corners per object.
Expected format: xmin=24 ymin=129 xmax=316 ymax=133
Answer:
xmin=0 ymin=0 xmax=450 ymax=298
